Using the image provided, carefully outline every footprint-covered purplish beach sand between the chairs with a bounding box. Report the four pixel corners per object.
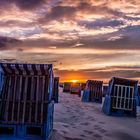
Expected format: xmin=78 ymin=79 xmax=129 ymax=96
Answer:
xmin=51 ymin=88 xmax=140 ymax=140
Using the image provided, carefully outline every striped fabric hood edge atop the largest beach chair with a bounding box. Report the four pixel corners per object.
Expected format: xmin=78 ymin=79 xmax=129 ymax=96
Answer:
xmin=0 ymin=63 xmax=52 ymax=75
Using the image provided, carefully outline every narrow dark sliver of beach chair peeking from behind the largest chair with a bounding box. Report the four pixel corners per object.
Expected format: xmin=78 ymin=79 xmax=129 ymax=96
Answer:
xmin=53 ymin=77 xmax=59 ymax=103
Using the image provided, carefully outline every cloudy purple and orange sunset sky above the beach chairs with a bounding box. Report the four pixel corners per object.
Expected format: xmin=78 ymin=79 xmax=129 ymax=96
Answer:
xmin=0 ymin=0 xmax=140 ymax=82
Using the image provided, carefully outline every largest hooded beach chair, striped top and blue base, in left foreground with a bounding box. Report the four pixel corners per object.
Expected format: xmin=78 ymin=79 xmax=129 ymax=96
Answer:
xmin=0 ymin=63 xmax=54 ymax=140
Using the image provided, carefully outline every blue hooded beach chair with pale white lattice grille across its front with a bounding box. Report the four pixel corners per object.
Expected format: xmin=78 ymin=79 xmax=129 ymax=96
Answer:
xmin=102 ymin=77 xmax=138 ymax=117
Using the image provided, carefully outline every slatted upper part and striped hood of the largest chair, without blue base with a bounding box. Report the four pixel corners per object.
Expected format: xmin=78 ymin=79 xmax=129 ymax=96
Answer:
xmin=0 ymin=63 xmax=53 ymax=124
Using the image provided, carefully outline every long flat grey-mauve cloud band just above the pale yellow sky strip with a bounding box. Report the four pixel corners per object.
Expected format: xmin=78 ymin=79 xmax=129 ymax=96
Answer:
xmin=6 ymin=30 xmax=140 ymax=51
